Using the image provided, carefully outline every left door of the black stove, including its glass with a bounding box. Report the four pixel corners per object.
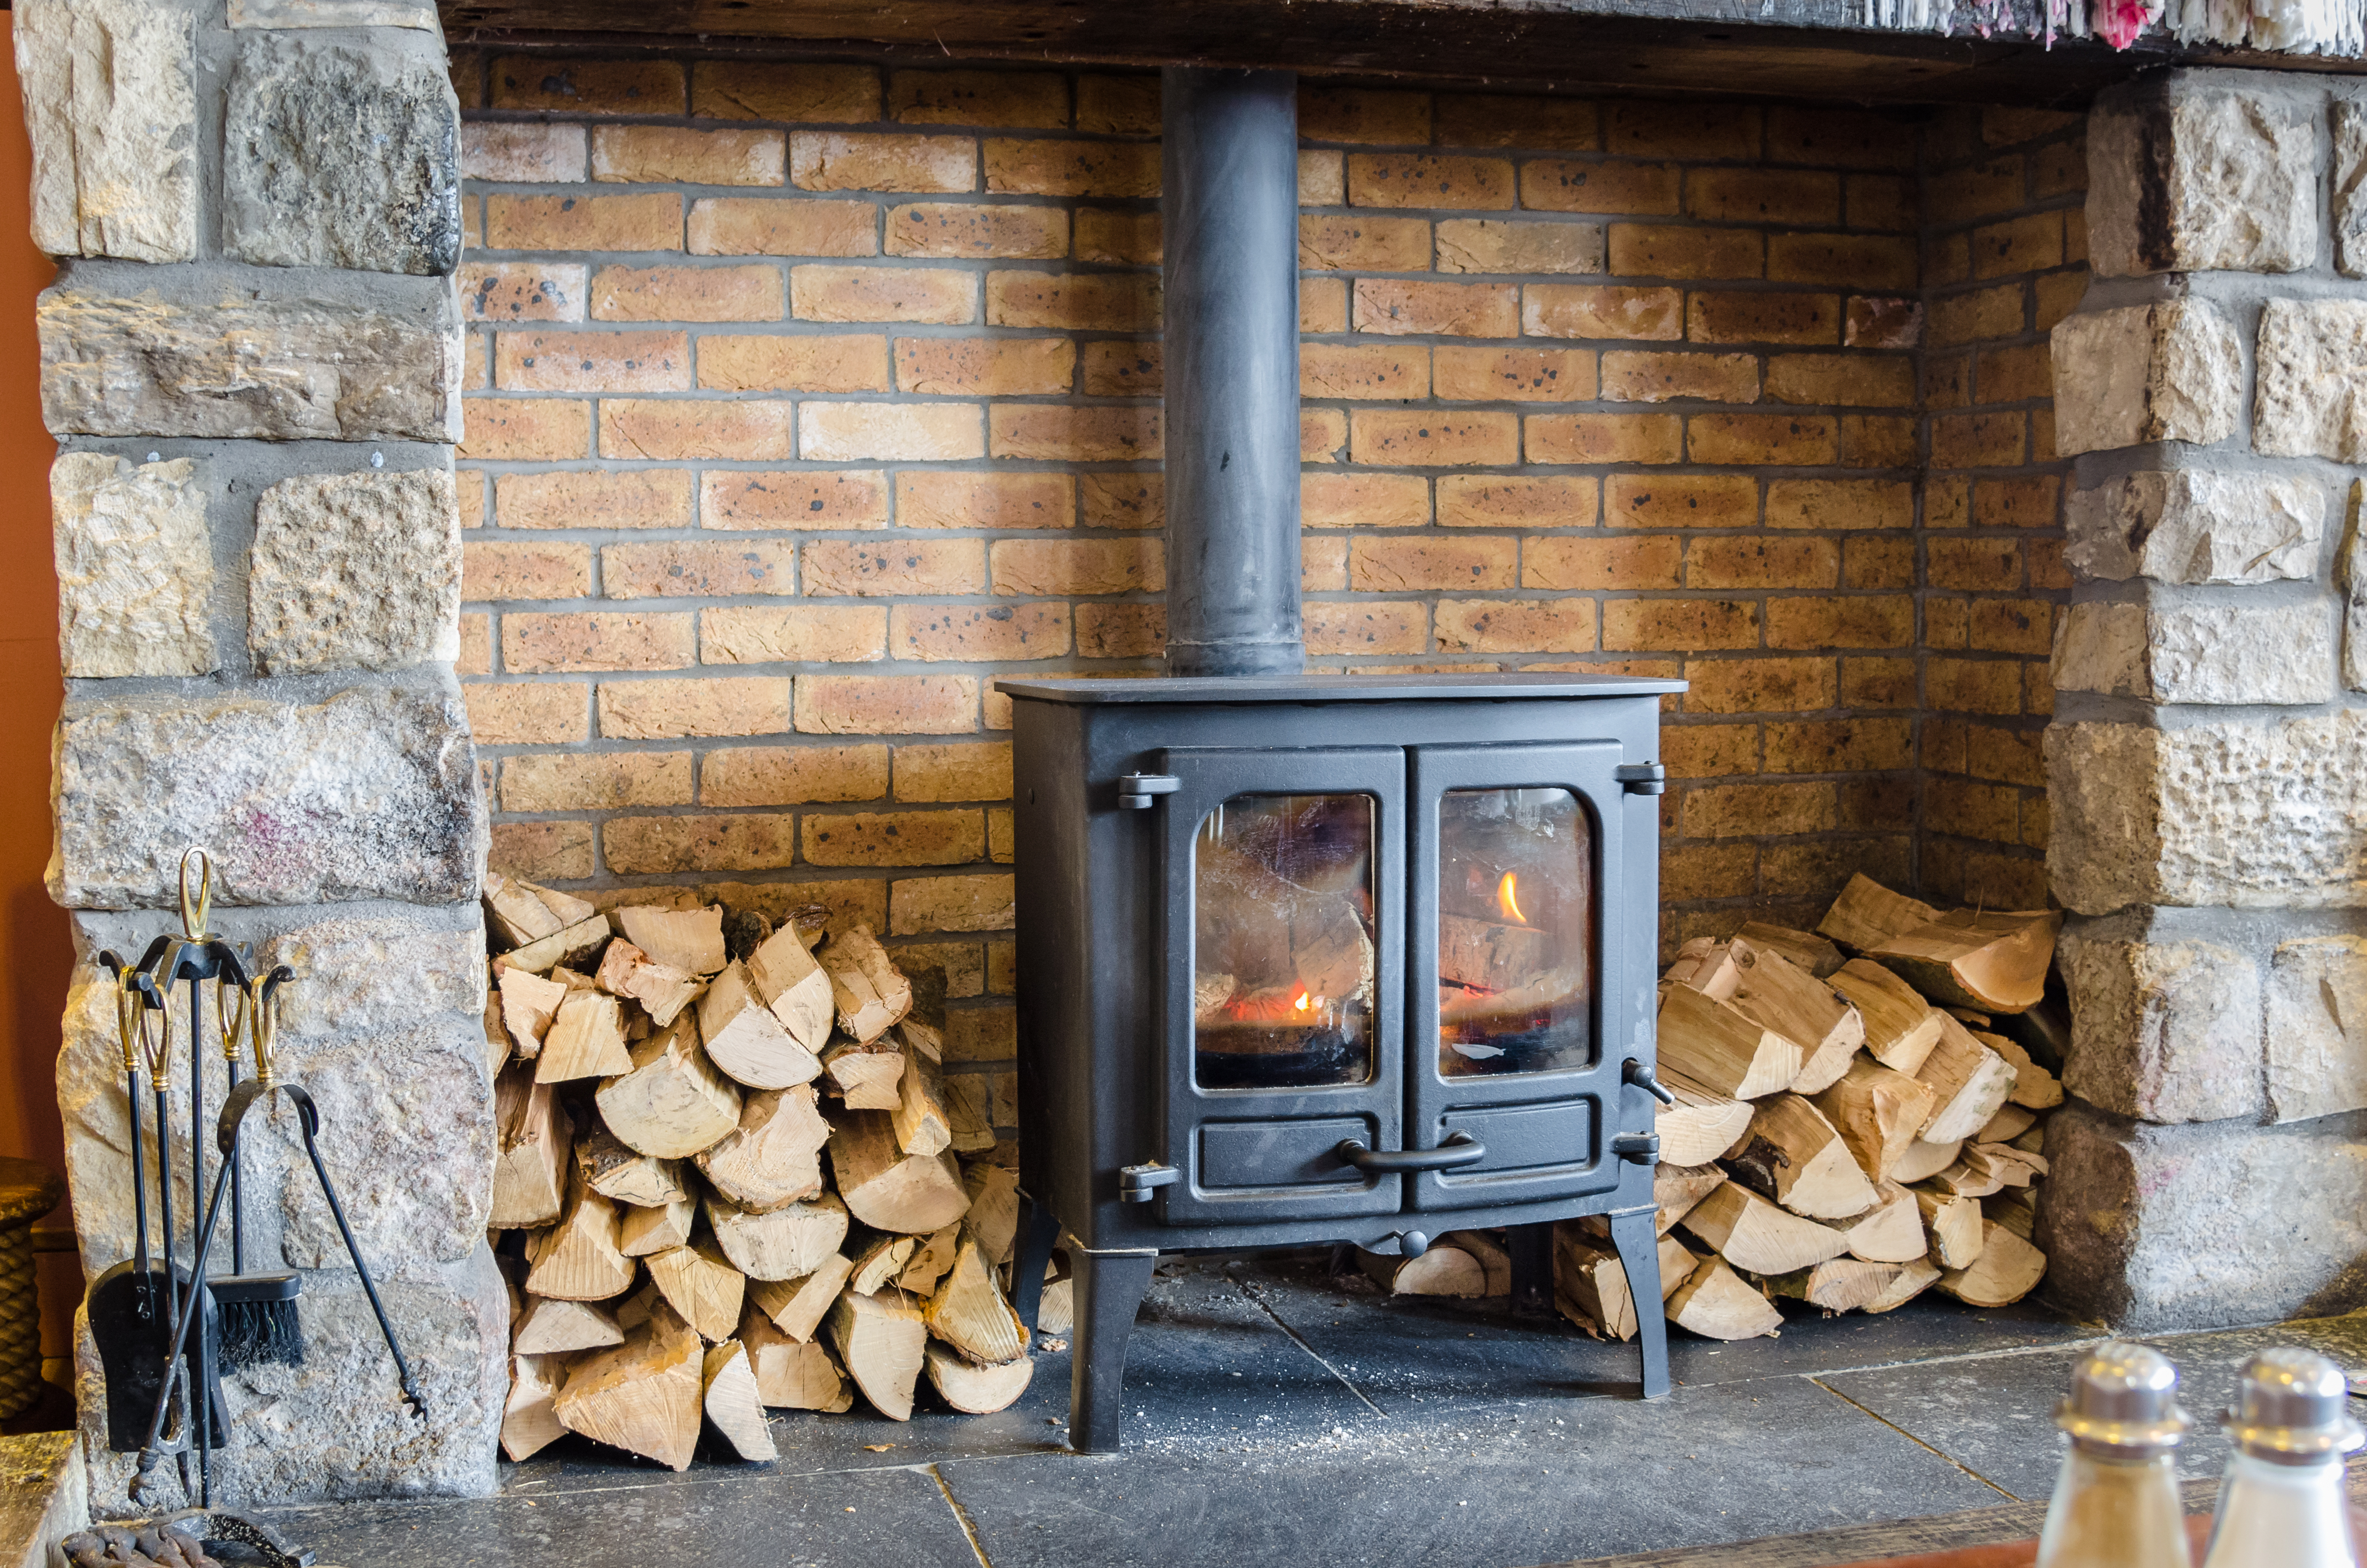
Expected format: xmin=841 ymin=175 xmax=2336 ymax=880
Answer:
xmin=1155 ymin=746 xmax=1406 ymax=1225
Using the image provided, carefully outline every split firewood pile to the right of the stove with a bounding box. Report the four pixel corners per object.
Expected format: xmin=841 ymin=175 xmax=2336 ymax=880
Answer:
xmin=1553 ymin=876 xmax=2064 ymax=1338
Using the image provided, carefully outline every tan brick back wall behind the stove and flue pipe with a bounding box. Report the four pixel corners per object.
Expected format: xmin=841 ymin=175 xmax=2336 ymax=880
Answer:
xmin=455 ymin=57 xmax=2059 ymax=1049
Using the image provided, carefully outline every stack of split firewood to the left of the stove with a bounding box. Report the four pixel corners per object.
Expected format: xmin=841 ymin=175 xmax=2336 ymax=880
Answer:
xmin=485 ymin=874 xmax=1034 ymax=1471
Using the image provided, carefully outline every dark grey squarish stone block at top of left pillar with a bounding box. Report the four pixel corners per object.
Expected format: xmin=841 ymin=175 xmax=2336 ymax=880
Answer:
xmin=223 ymin=33 xmax=459 ymax=277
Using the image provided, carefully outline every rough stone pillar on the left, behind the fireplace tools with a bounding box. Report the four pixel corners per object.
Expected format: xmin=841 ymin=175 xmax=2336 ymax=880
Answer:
xmin=17 ymin=0 xmax=507 ymax=1514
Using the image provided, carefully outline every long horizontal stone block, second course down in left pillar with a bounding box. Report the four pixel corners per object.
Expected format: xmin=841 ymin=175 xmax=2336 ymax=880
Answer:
xmin=38 ymin=263 xmax=462 ymax=441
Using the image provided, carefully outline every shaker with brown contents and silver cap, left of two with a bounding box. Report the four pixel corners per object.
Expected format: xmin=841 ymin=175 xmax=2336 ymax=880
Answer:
xmin=2038 ymin=1340 xmax=2194 ymax=1568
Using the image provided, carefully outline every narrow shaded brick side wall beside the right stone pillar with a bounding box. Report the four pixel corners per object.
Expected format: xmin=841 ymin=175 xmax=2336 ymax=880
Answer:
xmin=1917 ymin=109 xmax=2088 ymax=910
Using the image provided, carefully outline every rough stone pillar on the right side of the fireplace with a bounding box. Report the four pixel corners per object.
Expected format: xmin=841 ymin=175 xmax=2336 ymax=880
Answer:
xmin=2038 ymin=71 xmax=2367 ymax=1329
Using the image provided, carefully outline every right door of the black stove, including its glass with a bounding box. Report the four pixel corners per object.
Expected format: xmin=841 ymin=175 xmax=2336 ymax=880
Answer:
xmin=1406 ymin=741 xmax=1628 ymax=1208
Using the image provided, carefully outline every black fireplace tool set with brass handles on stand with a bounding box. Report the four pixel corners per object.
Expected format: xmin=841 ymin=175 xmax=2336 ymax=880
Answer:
xmin=90 ymin=848 xmax=426 ymax=1521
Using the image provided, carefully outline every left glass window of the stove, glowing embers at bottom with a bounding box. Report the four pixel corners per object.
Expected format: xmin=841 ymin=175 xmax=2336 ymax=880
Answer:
xmin=1193 ymin=796 xmax=1373 ymax=1089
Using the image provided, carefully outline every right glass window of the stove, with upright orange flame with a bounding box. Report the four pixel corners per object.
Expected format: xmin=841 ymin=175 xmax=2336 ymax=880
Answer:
xmin=1439 ymin=789 xmax=1595 ymax=1078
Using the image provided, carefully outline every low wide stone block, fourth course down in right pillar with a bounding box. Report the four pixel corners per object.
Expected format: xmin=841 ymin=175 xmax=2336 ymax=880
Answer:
xmin=2055 ymin=604 xmax=2334 ymax=706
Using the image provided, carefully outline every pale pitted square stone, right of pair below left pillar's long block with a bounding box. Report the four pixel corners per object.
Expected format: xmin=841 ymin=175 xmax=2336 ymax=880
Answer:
xmin=246 ymin=469 xmax=462 ymax=675
